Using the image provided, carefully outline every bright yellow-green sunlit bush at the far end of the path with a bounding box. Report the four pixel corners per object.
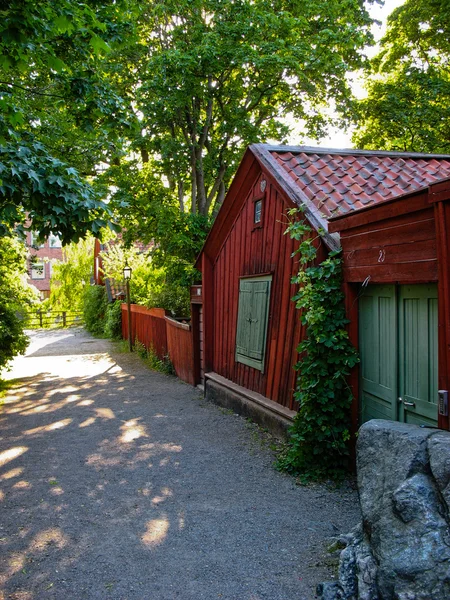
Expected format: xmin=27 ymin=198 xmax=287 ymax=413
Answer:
xmin=49 ymin=236 xmax=94 ymax=312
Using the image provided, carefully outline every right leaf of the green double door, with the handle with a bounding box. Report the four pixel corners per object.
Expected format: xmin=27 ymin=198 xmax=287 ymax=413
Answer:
xmin=398 ymin=284 xmax=438 ymax=425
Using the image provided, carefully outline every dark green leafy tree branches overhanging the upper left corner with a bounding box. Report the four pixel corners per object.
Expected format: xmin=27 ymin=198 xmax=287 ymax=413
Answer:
xmin=0 ymin=0 xmax=137 ymax=242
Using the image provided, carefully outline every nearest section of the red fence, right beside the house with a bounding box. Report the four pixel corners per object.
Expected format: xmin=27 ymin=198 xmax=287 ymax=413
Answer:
xmin=166 ymin=317 xmax=196 ymax=385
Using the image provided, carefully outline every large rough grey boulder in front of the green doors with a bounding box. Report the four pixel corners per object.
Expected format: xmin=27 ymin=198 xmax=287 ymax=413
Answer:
xmin=318 ymin=420 xmax=450 ymax=600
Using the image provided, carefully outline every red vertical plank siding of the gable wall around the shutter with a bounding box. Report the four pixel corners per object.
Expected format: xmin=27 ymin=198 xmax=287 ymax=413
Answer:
xmin=211 ymin=171 xmax=302 ymax=409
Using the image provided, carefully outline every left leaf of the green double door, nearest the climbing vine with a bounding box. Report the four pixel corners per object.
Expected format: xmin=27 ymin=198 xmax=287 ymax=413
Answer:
xmin=359 ymin=285 xmax=397 ymax=423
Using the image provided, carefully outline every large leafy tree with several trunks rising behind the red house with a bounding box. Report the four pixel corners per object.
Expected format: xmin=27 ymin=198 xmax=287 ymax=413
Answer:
xmin=110 ymin=0 xmax=372 ymax=216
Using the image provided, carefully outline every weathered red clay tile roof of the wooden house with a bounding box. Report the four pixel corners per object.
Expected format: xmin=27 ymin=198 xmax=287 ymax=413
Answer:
xmin=255 ymin=144 xmax=450 ymax=223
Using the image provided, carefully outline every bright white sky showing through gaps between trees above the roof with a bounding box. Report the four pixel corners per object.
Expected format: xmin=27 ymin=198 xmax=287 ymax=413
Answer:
xmin=289 ymin=0 xmax=405 ymax=148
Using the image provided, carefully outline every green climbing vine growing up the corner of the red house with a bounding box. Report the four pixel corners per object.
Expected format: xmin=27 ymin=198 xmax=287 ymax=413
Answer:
xmin=279 ymin=211 xmax=358 ymax=479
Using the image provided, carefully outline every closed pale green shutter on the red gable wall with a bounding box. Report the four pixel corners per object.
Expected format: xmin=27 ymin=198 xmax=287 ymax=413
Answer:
xmin=236 ymin=276 xmax=272 ymax=372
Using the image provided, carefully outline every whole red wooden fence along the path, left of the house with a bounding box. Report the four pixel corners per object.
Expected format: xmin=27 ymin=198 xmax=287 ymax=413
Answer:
xmin=122 ymin=304 xmax=196 ymax=385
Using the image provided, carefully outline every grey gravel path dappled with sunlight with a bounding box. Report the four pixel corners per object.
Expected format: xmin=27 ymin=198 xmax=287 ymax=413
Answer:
xmin=0 ymin=329 xmax=359 ymax=600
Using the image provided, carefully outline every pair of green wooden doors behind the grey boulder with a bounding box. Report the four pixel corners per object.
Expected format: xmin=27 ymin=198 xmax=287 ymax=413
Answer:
xmin=359 ymin=284 xmax=438 ymax=425
